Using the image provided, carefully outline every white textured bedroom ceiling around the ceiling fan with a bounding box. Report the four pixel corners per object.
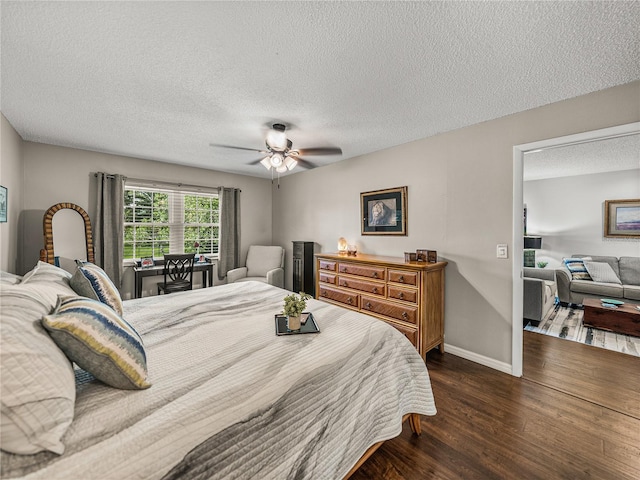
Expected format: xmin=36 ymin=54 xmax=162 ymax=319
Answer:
xmin=0 ymin=1 xmax=640 ymax=177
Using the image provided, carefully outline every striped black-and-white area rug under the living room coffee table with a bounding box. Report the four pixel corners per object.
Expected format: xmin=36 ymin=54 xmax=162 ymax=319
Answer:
xmin=524 ymin=305 xmax=640 ymax=357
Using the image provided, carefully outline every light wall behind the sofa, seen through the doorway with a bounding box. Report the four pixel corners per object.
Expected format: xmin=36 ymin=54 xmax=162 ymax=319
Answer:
xmin=523 ymin=168 xmax=640 ymax=268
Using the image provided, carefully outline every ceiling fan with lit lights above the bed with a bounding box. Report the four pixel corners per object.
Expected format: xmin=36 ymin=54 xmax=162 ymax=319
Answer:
xmin=209 ymin=123 xmax=342 ymax=174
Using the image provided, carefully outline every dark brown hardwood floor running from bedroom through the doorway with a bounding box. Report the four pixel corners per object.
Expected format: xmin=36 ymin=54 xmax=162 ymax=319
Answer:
xmin=351 ymin=332 xmax=640 ymax=480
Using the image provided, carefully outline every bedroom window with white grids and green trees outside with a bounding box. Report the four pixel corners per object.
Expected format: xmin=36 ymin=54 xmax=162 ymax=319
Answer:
xmin=123 ymin=185 xmax=220 ymax=259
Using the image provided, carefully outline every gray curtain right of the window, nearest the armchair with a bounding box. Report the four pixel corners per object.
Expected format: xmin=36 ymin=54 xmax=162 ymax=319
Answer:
xmin=218 ymin=187 xmax=240 ymax=280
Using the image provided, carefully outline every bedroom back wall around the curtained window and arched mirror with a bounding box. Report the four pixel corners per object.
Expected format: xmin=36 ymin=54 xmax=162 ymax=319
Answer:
xmin=21 ymin=142 xmax=272 ymax=298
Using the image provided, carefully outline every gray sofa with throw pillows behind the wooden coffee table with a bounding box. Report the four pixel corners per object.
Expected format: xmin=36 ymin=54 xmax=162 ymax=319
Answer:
xmin=555 ymin=254 xmax=640 ymax=305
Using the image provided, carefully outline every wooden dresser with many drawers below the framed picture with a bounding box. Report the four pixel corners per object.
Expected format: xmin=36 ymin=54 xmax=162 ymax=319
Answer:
xmin=315 ymin=253 xmax=447 ymax=360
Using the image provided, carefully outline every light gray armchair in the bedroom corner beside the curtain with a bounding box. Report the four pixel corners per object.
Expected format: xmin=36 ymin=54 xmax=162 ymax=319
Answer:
xmin=227 ymin=245 xmax=284 ymax=288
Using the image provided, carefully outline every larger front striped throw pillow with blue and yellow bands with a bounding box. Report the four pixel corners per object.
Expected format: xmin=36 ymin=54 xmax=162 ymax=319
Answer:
xmin=42 ymin=296 xmax=151 ymax=390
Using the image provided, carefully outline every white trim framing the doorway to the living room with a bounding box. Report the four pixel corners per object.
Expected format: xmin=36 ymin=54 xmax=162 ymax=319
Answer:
xmin=511 ymin=122 xmax=640 ymax=377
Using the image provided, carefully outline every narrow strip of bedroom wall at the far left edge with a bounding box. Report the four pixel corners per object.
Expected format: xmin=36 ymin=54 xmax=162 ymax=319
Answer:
xmin=0 ymin=110 xmax=23 ymax=273
